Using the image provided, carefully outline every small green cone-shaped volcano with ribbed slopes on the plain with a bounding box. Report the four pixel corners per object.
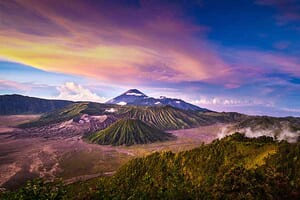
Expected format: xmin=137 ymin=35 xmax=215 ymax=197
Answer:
xmin=88 ymin=119 xmax=172 ymax=145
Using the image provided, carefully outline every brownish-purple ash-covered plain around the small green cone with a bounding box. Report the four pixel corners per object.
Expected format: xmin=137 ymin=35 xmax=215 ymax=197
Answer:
xmin=0 ymin=115 xmax=223 ymax=189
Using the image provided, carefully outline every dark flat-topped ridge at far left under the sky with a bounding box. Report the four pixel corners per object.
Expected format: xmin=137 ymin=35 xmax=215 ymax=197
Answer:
xmin=0 ymin=94 xmax=73 ymax=115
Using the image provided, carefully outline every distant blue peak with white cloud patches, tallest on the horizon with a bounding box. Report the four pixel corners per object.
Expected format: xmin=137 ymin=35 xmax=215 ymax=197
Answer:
xmin=107 ymin=89 xmax=209 ymax=112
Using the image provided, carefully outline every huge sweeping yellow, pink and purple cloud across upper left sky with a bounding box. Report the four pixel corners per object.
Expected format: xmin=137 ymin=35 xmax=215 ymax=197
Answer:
xmin=0 ymin=0 xmax=228 ymax=83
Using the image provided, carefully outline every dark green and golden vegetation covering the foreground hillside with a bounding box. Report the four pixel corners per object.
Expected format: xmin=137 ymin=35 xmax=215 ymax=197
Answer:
xmin=2 ymin=133 xmax=300 ymax=199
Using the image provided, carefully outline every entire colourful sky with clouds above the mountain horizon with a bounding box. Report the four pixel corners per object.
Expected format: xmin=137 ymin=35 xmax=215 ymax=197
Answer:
xmin=0 ymin=0 xmax=300 ymax=116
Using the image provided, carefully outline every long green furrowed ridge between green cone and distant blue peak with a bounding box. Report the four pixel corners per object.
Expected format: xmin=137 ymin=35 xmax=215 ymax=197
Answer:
xmin=20 ymin=102 xmax=247 ymax=130
